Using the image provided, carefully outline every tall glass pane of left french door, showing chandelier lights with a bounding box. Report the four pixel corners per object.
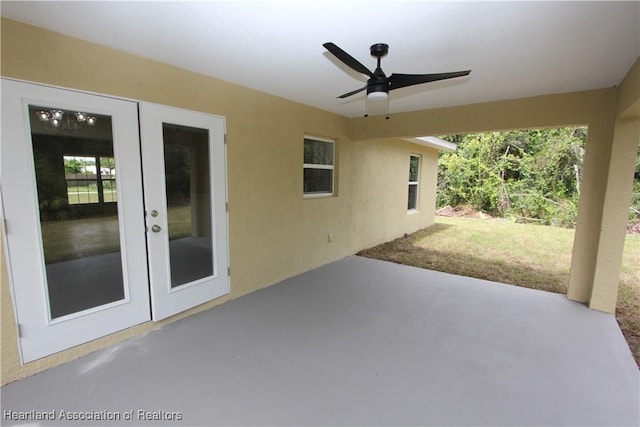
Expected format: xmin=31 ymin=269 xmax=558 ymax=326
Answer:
xmin=29 ymin=106 xmax=125 ymax=319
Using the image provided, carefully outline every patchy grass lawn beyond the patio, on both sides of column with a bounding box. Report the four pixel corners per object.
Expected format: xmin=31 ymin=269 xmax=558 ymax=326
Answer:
xmin=358 ymin=216 xmax=640 ymax=366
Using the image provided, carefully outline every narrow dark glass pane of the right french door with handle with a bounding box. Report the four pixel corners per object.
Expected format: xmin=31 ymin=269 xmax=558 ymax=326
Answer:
xmin=162 ymin=123 xmax=213 ymax=288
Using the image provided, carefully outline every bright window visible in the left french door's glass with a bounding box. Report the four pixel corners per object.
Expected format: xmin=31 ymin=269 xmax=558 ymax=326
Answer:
xmin=64 ymin=156 xmax=116 ymax=205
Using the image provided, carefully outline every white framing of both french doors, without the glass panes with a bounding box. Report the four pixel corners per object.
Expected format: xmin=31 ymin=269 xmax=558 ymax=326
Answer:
xmin=0 ymin=78 xmax=230 ymax=363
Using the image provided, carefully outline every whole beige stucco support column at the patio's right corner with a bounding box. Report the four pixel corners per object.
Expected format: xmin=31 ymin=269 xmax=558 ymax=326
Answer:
xmin=567 ymin=58 xmax=640 ymax=313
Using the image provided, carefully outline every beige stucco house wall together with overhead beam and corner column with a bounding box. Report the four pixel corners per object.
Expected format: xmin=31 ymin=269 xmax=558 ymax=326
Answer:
xmin=0 ymin=19 xmax=640 ymax=383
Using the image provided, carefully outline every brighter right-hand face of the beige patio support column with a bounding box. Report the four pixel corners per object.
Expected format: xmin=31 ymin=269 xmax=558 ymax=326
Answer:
xmin=589 ymin=119 xmax=640 ymax=313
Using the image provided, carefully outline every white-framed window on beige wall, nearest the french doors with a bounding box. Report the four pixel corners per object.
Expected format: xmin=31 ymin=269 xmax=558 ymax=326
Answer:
xmin=303 ymin=136 xmax=335 ymax=197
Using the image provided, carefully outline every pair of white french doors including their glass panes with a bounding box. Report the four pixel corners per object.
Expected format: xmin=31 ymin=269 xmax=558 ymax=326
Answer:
xmin=0 ymin=79 xmax=228 ymax=362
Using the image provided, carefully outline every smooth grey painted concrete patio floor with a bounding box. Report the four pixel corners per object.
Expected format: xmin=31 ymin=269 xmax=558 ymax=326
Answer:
xmin=2 ymin=256 xmax=640 ymax=426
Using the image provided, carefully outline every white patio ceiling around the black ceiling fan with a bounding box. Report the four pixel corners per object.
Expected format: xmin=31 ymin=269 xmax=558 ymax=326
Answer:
xmin=0 ymin=0 xmax=640 ymax=117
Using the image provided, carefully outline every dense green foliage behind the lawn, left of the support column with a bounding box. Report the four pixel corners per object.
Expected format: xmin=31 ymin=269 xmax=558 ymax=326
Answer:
xmin=437 ymin=127 xmax=587 ymax=227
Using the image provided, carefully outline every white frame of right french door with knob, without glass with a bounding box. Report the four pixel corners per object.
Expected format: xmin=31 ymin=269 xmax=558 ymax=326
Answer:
xmin=140 ymin=102 xmax=230 ymax=321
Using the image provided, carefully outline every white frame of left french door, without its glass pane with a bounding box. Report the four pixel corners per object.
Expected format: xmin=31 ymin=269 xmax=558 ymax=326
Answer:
xmin=0 ymin=79 xmax=150 ymax=363
